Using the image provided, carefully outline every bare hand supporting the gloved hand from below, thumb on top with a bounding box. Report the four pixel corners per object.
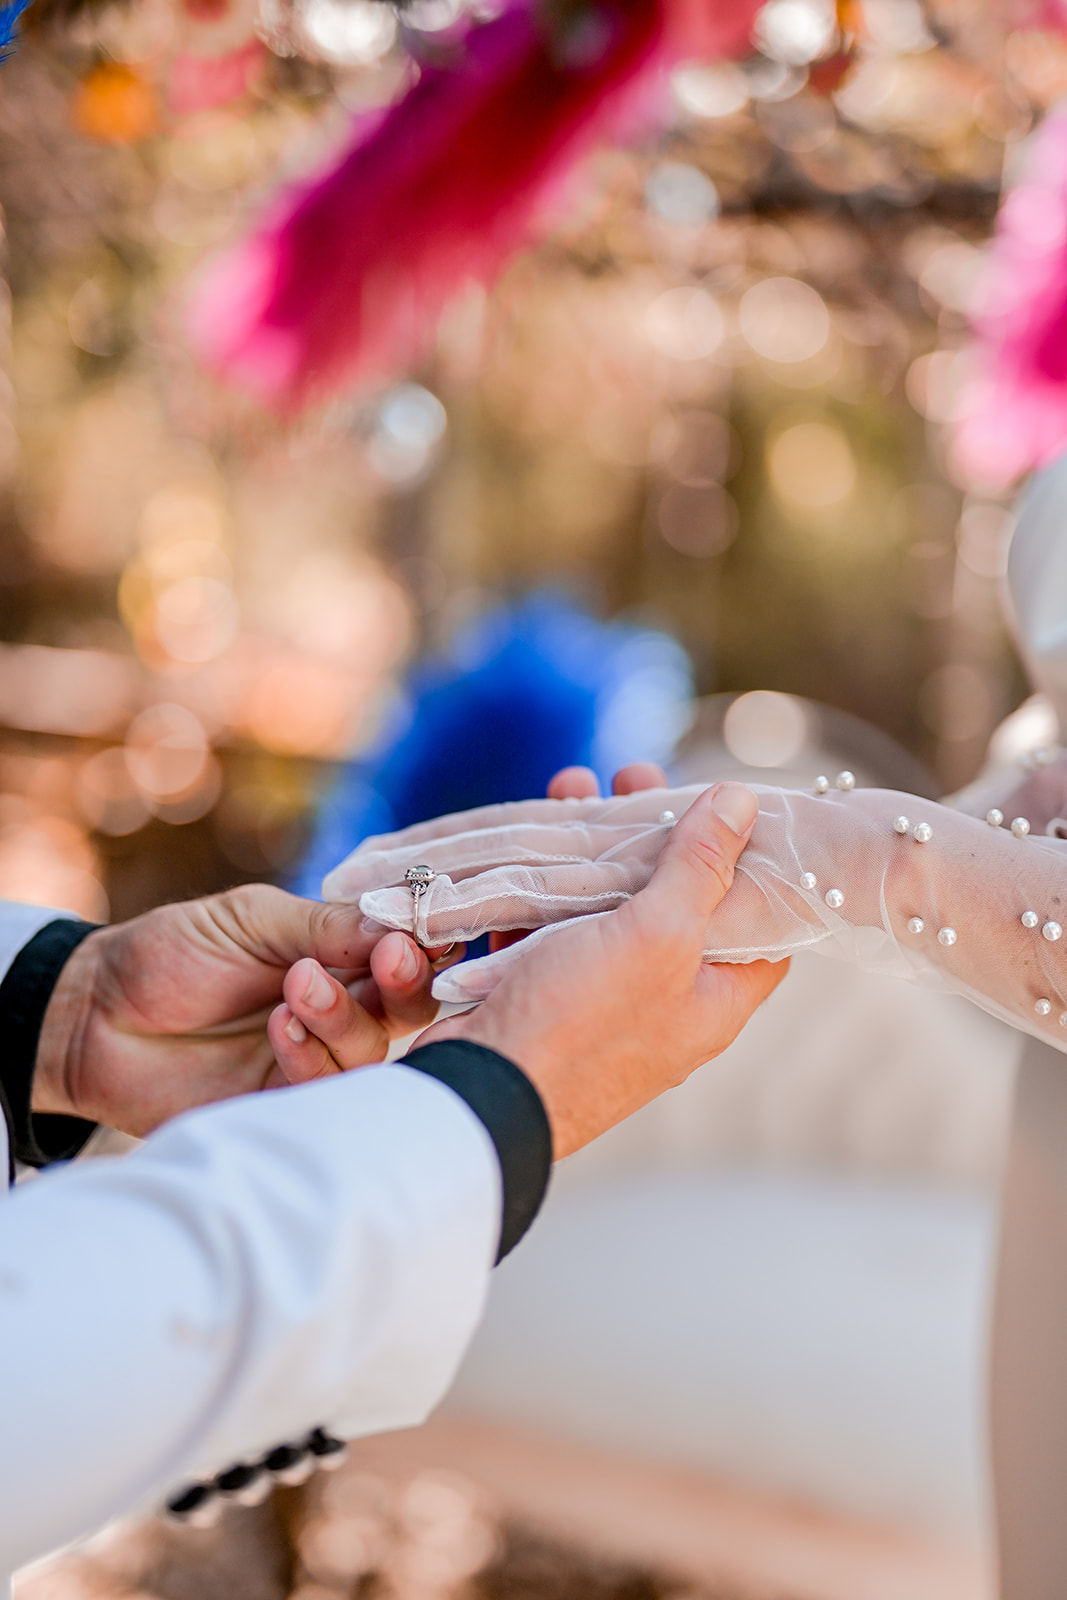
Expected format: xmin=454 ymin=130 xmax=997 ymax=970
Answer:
xmin=279 ymin=784 xmax=787 ymax=1158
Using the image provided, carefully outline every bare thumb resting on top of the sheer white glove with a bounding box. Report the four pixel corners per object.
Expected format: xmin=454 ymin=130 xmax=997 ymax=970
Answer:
xmin=630 ymin=784 xmax=760 ymax=955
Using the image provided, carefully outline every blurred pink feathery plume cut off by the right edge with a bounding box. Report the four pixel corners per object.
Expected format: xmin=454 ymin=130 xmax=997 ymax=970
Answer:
xmin=953 ymin=110 xmax=1067 ymax=486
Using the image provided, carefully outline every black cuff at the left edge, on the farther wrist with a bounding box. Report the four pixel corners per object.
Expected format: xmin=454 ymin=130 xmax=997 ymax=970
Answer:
xmin=0 ymin=917 xmax=96 ymax=1178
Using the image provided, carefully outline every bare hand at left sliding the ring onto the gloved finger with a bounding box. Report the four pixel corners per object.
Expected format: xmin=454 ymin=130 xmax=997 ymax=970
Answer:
xmin=34 ymin=883 xmax=447 ymax=1136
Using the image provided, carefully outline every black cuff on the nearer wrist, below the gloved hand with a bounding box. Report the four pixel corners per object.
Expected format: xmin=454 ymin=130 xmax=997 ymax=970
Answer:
xmin=398 ymin=1036 xmax=552 ymax=1261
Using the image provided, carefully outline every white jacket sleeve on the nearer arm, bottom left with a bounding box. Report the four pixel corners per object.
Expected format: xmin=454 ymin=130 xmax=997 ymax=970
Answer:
xmin=0 ymin=1066 xmax=501 ymax=1573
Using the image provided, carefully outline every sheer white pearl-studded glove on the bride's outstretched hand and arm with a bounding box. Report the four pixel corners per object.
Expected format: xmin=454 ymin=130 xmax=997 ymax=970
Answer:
xmin=325 ymin=778 xmax=1067 ymax=1050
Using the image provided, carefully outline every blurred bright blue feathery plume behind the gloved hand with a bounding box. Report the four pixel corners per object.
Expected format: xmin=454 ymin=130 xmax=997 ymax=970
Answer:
xmin=293 ymin=590 xmax=693 ymax=896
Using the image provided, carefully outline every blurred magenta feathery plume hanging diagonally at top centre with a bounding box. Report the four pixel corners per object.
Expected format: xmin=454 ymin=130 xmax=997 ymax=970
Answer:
xmin=187 ymin=0 xmax=760 ymax=413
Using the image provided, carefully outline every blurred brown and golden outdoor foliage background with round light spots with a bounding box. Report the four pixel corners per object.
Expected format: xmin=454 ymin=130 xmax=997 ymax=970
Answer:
xmin=0 ymin=0 xmax=1043 ymax=917
